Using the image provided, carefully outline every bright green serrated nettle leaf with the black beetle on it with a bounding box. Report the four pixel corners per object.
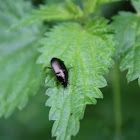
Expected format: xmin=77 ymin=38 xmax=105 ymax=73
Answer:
xmin=38 ymin=19 xmax=115 ymax=140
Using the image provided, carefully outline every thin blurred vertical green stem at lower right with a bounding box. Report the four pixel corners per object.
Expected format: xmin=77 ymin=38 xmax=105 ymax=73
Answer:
xmin=112 ymin=62 xmax=122 ymax=140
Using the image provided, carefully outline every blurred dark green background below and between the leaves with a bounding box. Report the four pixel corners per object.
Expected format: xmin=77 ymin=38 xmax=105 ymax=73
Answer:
xmin=0 ymin=0 xmax=140 ymax=140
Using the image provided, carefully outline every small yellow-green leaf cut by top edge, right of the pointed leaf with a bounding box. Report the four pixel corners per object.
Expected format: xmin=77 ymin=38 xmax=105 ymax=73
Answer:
xmin=83 ymin=0 xmax=119 ymax=14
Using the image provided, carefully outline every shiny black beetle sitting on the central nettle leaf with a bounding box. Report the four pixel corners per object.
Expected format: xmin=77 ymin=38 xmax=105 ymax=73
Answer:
xmin=44 ymin=58 xmax=69 ymax=88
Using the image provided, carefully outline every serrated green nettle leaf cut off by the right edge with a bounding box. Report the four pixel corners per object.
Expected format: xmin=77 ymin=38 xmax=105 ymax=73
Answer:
xmin=112 ymin=12 xmax=140 ymax=85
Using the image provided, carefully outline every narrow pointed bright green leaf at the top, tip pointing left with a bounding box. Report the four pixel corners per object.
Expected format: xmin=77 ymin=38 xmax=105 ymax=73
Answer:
xmin=15 ymin=0 xmax=83 ymax=27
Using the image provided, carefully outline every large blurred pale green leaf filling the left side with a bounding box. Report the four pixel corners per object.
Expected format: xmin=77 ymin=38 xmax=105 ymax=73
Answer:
xmin=0 ymin=0 xmax=43 ymax=117
